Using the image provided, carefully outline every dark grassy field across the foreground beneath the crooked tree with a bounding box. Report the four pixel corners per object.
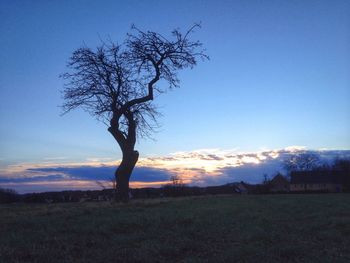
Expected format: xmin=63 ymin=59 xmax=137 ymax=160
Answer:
xmin=0 ymin=194 xmax=350 ymax=263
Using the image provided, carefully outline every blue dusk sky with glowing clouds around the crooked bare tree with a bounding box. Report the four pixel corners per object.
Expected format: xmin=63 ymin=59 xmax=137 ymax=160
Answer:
xmin=0 ymin=0 xmax=350 ymax=192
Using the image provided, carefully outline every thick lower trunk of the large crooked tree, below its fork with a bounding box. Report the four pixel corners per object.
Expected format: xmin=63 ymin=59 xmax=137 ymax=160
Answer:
xmin=115 ymin=151 xmax=139 ymax=203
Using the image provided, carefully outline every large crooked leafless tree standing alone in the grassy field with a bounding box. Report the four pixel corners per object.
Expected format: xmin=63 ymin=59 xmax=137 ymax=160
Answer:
xmin=62 ymin=24 xmax=208 ymax=202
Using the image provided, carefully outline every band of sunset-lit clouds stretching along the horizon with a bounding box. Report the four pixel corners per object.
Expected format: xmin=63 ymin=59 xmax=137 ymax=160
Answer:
xmin=0 ymin=146 xmax=350 ymax=192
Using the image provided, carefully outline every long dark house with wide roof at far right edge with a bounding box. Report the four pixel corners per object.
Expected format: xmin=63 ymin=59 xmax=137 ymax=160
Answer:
xmin=290 ymin=170 xmax=344 ymax=192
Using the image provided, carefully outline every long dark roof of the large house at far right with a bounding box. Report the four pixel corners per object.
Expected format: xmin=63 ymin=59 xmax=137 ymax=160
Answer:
xmin=291 ymin=170 xmax=343 ymax=184
